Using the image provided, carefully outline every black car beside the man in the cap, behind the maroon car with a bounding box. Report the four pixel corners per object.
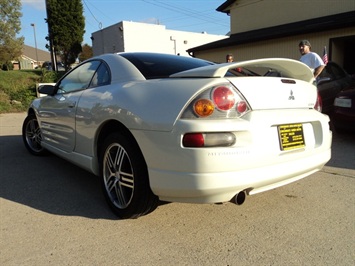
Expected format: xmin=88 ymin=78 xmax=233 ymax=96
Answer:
xmin=317 ymin=62 xmax=355 ymax=114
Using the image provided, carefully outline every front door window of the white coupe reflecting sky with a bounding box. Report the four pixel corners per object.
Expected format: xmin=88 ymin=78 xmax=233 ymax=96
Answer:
xmin=58 ymin=61 xmax=101 ymax=93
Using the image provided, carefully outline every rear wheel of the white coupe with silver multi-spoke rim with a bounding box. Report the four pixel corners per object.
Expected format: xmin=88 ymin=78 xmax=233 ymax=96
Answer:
xmin=100 ymin=132 xmax=159 ymax=219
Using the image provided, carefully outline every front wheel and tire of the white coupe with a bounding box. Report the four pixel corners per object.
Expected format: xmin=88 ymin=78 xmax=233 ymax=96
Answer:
xmin=22 ymin=114 xmax=47 ymax=156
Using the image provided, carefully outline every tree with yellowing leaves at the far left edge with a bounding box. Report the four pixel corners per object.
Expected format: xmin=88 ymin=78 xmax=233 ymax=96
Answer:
xmin=0 ymin=0 xmax=24 ymax=66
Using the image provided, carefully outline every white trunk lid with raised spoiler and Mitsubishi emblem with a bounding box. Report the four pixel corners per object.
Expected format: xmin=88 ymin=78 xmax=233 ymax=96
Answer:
xmin=170 ymin=58 xmax=317 ymax=110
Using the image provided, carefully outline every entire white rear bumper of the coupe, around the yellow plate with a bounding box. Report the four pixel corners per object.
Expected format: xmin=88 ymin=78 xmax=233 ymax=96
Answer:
xmin=133 ymin=110 xmax=332 ymax=203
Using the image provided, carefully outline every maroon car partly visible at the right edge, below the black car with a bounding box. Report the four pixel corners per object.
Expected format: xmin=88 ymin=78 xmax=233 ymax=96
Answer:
xmin=332 ymin=87 xmax=355 ymax=132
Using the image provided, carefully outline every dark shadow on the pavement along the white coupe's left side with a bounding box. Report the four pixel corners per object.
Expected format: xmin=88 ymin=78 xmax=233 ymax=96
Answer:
xmin=0 ymin=136 xmax=117 ymax=220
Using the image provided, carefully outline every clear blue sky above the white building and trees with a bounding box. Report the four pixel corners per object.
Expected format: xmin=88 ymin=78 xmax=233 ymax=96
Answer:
xmin=18 ymin=0 xmax=230 ymax=50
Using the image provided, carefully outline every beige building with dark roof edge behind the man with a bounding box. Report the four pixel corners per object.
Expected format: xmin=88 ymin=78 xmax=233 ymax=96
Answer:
xmin=187 ymin=0 xmax=355 ymax=74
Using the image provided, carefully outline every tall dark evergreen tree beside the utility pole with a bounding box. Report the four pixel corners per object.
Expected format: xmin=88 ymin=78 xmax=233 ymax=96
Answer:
xmin=46 ymin=0 xmax=85 ymax=69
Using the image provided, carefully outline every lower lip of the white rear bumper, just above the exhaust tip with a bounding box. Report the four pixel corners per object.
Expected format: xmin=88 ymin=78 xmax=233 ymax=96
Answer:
xmin=149 ymin=149 xmax=331 ymax=203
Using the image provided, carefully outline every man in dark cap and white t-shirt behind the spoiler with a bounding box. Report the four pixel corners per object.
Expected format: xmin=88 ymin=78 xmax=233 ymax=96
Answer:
xmin=298 ymin=40 xmax=325 ymax=78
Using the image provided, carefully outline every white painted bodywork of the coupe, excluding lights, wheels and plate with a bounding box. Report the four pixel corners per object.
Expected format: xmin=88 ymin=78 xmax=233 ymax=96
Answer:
xmin=25 ymin=55 xmax=332 ymax=216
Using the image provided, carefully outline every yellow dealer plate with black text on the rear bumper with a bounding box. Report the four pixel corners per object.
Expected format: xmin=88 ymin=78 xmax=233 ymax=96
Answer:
xmin=277 ymin=124 xmax=306 ymax=151
